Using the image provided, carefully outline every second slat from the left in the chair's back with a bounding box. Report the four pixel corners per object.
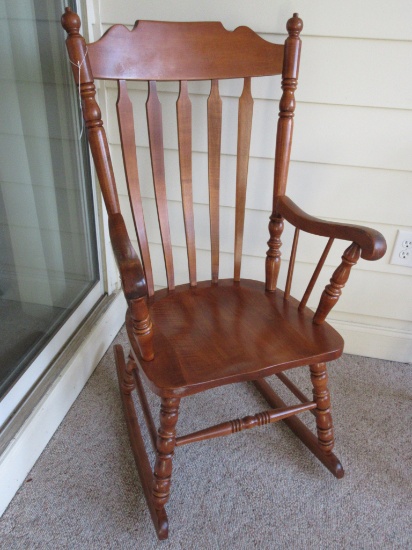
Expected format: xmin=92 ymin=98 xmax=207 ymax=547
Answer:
xmin=146 ymin=81 xmax=175 ymax=290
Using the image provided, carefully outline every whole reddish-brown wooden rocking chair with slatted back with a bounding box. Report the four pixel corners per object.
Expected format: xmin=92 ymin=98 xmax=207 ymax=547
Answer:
xmin=62 ymin=8 xmax=386 ymax=539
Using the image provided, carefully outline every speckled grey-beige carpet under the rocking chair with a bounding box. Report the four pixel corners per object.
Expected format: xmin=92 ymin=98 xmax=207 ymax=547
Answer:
xmin=0 ymin=333 xmax=412 ymax=550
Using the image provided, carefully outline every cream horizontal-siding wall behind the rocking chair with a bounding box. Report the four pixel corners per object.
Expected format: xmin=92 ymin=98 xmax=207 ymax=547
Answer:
xmin=95 ymin=0 xmax=412 ymax=361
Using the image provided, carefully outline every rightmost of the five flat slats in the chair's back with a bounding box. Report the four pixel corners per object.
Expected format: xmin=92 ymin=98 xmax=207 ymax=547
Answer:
xmin=234 ymin=77 xmax=253 ymax=281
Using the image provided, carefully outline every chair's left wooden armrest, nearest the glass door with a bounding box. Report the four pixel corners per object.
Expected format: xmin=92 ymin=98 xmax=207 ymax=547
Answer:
xmin=109 ymin=214 xmax=147 ymax=302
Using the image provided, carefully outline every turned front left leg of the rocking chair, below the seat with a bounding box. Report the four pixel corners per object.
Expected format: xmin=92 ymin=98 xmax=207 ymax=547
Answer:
xmin=152 ymin=398 xmax=180 ymax=510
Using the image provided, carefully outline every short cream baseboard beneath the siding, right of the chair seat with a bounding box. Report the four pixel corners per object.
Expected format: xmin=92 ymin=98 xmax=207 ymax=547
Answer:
xmin=328 ymin=319 xmax=412 ymax=363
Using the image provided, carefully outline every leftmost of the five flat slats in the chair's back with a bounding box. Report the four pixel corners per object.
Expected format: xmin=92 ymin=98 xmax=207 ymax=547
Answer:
xmin=116 ymin=80 xmax=154 ymax=296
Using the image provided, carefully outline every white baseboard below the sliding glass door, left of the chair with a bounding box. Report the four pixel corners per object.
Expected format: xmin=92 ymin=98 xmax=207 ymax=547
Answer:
xmin=0 ymin=293 xmax=126 ymax=516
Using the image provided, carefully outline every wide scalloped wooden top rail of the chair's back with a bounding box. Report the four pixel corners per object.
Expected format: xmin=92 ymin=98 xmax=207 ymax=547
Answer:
xmin=88 ymin=21 xmax=284 ymax=80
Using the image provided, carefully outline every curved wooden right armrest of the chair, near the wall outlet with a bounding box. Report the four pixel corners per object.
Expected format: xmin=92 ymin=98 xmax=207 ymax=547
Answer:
xmin=276 ymin=196 xmax=386 ymax=260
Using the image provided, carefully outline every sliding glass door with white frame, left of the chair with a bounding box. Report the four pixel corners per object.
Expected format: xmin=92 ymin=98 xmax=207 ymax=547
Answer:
xmin=0 ymin=0 xmax=103 ymax=426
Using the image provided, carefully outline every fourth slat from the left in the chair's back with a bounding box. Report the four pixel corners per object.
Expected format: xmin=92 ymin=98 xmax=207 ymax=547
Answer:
xmin=207 ymin=80 xmax=222 ymax=282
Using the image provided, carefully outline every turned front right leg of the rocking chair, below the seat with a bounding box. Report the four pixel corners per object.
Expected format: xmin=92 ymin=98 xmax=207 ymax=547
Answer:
xmin=310 ymin=363 xmax=334 ymax=453
